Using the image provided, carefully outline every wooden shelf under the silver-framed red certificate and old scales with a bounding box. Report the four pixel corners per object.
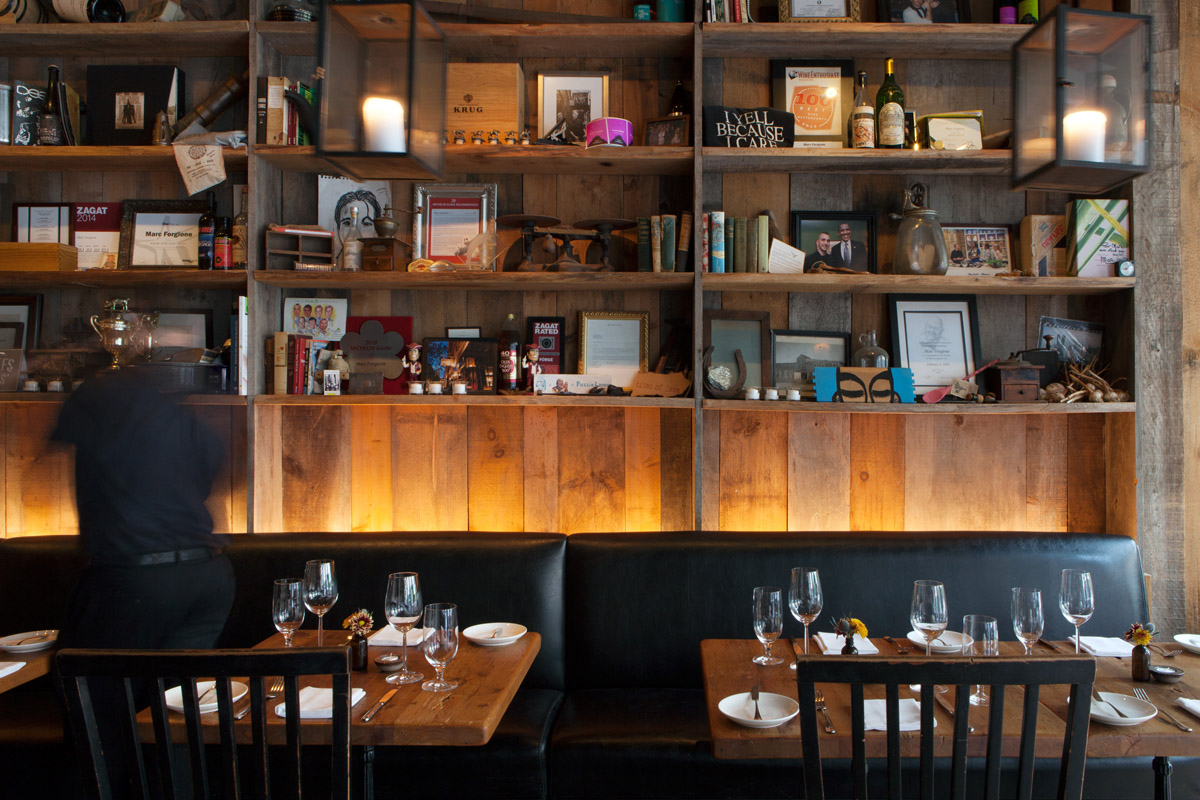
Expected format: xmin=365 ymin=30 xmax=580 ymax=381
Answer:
xmin=254 ymin=270 xmax=695 ymax=291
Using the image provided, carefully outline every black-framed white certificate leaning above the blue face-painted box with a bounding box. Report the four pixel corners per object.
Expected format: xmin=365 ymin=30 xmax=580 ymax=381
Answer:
xmin=888 ymin=295 xmax=980 ymax=395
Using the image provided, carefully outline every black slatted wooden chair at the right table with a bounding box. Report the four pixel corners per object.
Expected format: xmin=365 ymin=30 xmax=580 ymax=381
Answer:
xmin=797 ymin=655 xmax=1096 ymax=800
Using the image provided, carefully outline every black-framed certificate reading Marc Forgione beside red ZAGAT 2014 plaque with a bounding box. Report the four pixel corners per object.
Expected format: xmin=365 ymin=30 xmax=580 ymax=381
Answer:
xmin=116 ymin=199 xmax=208 ymax=270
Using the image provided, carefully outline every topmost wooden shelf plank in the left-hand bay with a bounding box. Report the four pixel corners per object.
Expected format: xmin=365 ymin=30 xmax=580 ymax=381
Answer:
xmin=0 ymin=19 xmax=250 ymax=56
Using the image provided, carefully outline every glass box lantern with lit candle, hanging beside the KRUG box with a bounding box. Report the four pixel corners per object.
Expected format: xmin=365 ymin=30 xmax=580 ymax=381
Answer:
xmin=317 ymin=0 xmax=446 ymax=180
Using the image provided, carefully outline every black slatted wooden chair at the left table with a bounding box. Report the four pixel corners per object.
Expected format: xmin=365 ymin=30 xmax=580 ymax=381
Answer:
xmin=56 ymin=648 xmax=350 ymax=800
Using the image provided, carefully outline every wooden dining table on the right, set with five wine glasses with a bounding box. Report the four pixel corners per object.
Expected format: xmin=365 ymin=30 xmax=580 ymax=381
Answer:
xmin=701 ymin=639 xmax=1200 ymax=800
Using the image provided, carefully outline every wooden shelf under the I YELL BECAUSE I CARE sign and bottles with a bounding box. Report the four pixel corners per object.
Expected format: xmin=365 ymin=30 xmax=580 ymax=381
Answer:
xmin=701 ymin=148 xmax=1013 ymax=175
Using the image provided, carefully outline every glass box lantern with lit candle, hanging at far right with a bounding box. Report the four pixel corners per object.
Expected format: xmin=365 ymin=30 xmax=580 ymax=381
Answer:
xmin=1013 ymin=6 xmax=1152 ymax=194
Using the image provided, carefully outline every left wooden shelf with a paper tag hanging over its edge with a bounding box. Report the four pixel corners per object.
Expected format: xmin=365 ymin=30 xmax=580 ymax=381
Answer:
xmin=0 ymin=146 xmax=246 ymax=173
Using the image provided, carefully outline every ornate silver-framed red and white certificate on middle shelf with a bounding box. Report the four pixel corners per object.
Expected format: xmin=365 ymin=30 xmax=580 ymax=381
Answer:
xmin=413 ymin=184 xmax=497 ymax=264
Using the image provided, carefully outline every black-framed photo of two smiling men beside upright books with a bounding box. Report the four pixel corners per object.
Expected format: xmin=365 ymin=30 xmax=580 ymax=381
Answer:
xmin=792 ymin=211 xmax=878 ymax=272
